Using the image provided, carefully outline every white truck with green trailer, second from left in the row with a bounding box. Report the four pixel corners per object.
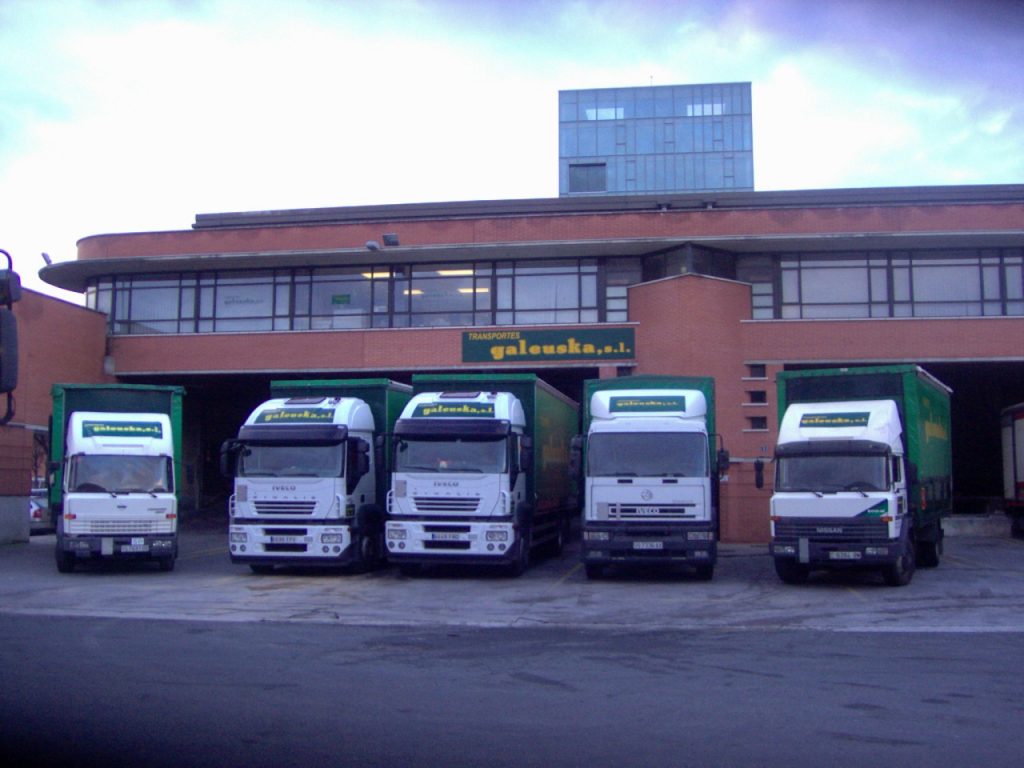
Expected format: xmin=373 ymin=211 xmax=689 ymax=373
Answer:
xmin=221 ymin=379 xmax=412 ymax=573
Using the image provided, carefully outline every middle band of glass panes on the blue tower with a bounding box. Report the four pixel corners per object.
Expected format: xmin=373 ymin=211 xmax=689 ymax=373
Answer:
xmin=558 ymin=117 xmax=754 ymax=158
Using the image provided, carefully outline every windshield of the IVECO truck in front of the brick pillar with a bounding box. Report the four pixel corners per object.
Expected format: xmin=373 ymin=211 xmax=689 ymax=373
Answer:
xmin=587 ymin=432 xmax=708 ymax=477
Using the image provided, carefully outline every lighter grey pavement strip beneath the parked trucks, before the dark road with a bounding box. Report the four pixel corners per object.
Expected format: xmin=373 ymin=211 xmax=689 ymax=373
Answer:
xmin=0 ymin=525 xmax=1024 ymax=633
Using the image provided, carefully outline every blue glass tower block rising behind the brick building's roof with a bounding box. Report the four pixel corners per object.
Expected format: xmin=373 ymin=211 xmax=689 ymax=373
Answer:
xmin=558 ymin=83 xmax=754 ymax=197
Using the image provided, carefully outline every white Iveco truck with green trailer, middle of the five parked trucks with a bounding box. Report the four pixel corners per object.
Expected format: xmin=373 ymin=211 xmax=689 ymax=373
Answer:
xmin=387 ymin=374 xmax=579 ymax=575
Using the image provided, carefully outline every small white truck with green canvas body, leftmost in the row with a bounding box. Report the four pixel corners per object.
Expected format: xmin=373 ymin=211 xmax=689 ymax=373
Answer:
xmin=49 ymin=384 xmax=184 ymax=573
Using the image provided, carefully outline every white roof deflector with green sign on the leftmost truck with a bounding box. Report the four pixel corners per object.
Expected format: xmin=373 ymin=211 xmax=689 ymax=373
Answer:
xmin=67 ymin=411 xmax=174 ymax=456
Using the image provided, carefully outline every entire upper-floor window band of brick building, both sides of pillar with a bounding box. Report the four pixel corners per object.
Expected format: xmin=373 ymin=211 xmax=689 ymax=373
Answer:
xmin=86 ymin=248 xmax=1024 ymax=334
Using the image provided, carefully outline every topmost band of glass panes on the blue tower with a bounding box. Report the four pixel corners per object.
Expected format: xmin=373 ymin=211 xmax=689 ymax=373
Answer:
xmin=558 ymin=83 xmax=751 ymax=123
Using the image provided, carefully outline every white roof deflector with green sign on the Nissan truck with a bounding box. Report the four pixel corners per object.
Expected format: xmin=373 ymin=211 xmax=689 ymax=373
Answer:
xmin=778 ymin=400 xmax=903 ymax=451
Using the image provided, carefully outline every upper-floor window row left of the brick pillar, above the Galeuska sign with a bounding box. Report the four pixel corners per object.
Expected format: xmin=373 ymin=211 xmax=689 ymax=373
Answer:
xmin=86 ymin=259 xmax=641 ymax=334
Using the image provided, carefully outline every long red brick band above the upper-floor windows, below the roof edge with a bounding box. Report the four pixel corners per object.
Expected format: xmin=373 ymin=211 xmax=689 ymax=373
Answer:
xmin=78 ymin=203 xmax=1024 ymax=260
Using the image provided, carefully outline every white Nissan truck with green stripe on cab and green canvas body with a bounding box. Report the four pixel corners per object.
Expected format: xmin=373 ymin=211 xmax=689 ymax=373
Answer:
xmin=771 ymin=366 xmax=952 ymax=587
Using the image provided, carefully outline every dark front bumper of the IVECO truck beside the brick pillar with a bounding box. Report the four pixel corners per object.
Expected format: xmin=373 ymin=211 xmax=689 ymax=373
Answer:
xmin=583 ymin=520 xmax=718 ymax=565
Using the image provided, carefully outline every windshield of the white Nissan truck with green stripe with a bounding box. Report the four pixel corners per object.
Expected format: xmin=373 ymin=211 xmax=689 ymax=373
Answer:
xmin=775 ymin=454 xmax=889 ymax=494
